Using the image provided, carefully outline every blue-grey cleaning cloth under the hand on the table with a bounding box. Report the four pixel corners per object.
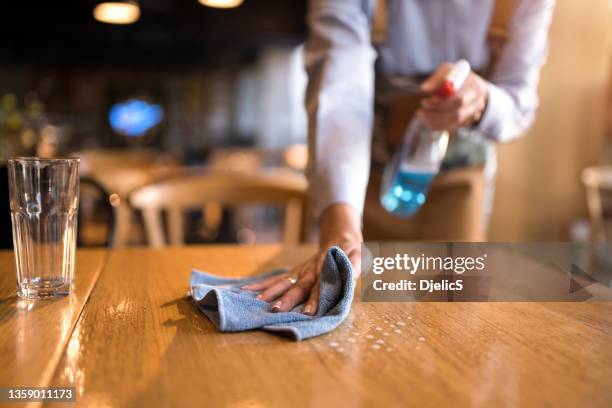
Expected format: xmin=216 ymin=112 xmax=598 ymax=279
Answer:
xmin=191 ymin=247 xmax=355 ymax=341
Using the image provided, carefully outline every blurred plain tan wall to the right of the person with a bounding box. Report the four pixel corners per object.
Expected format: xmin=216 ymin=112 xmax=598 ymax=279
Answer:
xmin=489 ymin=0 xmax=612 ymax=241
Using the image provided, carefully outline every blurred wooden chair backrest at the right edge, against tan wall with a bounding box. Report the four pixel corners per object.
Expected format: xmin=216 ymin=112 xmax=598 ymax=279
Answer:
xmin=582 ymin=166 xmax=612 ymax=241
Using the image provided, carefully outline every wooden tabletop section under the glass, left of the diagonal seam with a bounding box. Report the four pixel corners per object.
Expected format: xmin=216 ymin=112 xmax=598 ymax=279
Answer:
xmin=0 ymin=250 xmax=106 ymax=387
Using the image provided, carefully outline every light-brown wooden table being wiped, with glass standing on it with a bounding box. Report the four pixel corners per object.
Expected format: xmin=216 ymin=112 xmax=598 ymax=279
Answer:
xmin=0 ymin=246 xmax=612 ymax=407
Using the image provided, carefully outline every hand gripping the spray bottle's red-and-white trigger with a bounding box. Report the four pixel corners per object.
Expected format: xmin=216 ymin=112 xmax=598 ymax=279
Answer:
xmin=417 ymin=63 xmax=488 ymax=130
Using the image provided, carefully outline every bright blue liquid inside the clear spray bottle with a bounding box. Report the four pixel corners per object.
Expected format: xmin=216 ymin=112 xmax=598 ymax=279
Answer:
xmin=380 ymin=168 xmax=436 ymax=217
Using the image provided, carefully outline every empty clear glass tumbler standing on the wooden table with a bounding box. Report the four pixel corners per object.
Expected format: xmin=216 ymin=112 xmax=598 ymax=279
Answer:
xmin=8 ymin=157 xmax=79 ymax=299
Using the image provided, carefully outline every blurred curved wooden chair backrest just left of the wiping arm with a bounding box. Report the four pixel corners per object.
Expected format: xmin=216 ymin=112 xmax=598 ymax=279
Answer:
xmin=130 ymin=170 xmax=306 ymax=247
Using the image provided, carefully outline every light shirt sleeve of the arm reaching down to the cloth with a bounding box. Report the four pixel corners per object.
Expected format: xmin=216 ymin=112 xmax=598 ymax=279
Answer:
xmin=305 ymin=0 xmax=375 ymax=218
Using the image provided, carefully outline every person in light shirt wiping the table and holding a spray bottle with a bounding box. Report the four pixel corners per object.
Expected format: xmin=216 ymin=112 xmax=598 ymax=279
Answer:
xmin=245 ymin=0 xmax=554 ymax=315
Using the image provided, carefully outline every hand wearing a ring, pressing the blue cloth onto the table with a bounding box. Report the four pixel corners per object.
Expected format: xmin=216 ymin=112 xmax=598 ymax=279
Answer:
xmin=243 ymin=204 xmax=363 ymax=316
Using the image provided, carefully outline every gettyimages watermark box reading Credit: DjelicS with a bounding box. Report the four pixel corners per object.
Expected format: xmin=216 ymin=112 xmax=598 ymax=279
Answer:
xmin=361 ymin=242 xmax=612 ymax=302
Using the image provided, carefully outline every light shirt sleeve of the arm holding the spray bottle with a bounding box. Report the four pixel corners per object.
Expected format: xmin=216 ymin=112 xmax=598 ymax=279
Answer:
xmin=477 ymin=0 xmax=555 ymax=142
